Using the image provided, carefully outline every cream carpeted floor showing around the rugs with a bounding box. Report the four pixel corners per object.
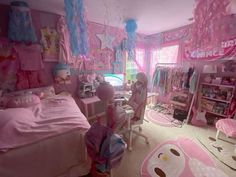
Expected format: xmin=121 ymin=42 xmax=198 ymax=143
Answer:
xmin=109 ymin=112 xmax=236 ymax=177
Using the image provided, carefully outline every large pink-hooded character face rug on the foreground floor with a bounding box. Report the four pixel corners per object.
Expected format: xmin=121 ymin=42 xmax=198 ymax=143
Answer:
xmin=141 ymin=138 xmax=227 ymax=177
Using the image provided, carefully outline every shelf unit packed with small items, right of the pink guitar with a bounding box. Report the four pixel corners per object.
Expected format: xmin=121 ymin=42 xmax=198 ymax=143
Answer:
xmin=200 ymin=80 xmax=235 ymax=118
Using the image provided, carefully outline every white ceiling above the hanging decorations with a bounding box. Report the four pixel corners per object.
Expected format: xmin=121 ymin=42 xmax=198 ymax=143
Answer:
xmin=0 ymin=0 xmax=195 ymax=34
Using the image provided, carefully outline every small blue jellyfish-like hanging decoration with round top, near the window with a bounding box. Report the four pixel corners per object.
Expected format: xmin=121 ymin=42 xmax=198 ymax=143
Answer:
xmin=125 ymin=19 xmax=138 ymax=59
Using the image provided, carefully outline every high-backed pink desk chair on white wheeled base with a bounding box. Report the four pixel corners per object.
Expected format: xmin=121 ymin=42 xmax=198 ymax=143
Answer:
xmin=115 ymin=73 xmax=149 ymax=151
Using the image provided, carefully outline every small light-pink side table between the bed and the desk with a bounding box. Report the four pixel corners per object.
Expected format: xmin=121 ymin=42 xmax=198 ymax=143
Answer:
xmin=80 ymin=96 xmax=105 ymax=120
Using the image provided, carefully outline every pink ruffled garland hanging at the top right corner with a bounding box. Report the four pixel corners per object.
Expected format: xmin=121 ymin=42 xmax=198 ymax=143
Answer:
xmin=192 ymin=0 xmax=230 ymax=49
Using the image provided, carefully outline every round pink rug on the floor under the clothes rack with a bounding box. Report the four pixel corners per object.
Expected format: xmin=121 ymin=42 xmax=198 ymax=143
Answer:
xmin=146 ymin=109 xmax=174 ymax=127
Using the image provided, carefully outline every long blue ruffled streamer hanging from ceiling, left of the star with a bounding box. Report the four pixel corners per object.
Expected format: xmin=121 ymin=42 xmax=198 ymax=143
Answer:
xmin=64 ymin=0 xmax=88 ymax=56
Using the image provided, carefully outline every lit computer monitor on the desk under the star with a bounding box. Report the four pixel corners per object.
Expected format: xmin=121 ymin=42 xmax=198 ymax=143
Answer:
xmin=104 ymin=74 xmax=124 ymax=87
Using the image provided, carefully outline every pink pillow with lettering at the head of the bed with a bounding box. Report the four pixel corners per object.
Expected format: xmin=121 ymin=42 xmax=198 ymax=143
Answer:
xmin=6 ymin=94 xmax=40 ymax=108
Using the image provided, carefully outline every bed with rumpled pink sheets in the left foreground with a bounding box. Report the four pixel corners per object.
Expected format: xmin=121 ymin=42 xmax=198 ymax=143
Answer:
xmin=0 ymin=87 xmax=90 ymax=177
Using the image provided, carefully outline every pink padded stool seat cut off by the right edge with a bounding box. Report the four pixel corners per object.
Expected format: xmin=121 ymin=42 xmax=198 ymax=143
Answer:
xmin=216 ymin=119 xmax=236 ymax=138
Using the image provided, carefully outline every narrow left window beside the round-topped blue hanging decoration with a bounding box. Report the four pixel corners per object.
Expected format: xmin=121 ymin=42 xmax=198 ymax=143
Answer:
xmin=126 ymin=48 xmax=145 ymax=80
